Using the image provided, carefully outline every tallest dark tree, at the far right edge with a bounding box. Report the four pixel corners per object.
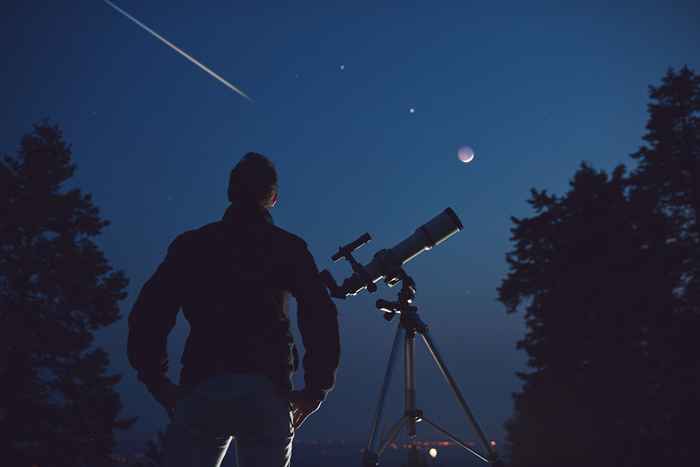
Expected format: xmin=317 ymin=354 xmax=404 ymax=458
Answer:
xmin=630 ymin=66 xmax=700 ymax=464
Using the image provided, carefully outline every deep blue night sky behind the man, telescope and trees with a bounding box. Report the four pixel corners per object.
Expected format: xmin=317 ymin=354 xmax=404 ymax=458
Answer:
xmin=0 ymin=0 xmax=700 ymax=452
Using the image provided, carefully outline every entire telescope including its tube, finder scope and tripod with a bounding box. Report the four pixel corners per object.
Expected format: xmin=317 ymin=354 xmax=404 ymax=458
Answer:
xmin=321 ymin=208 xmax=502 ymax=467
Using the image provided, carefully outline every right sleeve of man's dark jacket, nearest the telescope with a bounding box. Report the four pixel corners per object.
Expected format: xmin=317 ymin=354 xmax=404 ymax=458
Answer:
xmin=291 ymin=244 xmax=340 ymax=400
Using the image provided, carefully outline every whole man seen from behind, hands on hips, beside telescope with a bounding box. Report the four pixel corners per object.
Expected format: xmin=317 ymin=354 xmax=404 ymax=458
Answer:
xmin=127 ymin=153 xmax=340 ymax=467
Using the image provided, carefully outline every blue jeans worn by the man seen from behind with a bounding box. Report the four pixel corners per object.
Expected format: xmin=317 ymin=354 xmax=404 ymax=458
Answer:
xmin=163 ymin=373 xmax=294 ymax=467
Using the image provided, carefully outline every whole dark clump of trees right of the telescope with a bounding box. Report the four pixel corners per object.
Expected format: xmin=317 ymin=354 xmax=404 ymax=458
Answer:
xmin=498 ymin=68 xmax=700 ymax=466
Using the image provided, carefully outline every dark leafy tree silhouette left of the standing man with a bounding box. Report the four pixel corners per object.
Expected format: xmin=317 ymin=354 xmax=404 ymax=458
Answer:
xmin=0 ymin=122 xmax=135 ymax=467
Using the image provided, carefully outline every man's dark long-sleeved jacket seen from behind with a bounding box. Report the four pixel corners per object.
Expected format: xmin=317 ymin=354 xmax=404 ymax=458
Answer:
xmin=127 ymin=204 xmax=340 ymax=399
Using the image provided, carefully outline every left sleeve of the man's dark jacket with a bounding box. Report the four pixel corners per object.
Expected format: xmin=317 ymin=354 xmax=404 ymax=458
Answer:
xmin=127 ymin=235 xmax=183 ymax=389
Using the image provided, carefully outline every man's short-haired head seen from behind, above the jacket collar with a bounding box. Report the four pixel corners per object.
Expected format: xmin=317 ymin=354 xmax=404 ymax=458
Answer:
xmin=228 ymin=152 xmax=277 ymax=209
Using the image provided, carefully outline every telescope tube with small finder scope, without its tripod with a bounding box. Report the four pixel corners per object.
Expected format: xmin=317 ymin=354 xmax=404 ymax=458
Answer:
xmin=321 ymin=208 xmax=464 ymax=299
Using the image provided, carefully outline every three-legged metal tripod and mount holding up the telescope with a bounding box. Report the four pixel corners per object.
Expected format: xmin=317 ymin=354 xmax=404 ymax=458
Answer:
xmin=362 ymin=269 xmax=499 ymax=467
